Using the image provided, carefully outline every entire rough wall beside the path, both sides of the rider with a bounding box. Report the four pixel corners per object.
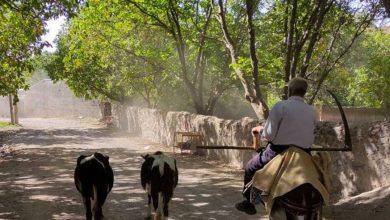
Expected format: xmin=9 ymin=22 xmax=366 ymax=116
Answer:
xmin=118 ymin=107 xmax=390 ymax=200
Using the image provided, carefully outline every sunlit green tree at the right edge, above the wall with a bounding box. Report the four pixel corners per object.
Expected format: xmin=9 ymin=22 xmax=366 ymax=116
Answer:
xmin=330 ymin=28 xmax=390 ymax=114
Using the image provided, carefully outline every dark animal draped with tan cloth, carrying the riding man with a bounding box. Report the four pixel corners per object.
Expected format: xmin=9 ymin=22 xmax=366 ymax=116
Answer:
xmin=252 ymin=147 xmax=330 ymax=220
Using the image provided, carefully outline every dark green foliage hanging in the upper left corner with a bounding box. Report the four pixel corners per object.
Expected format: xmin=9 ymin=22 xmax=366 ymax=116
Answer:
xmin=0 ymin=0 xmax=77 ymax=95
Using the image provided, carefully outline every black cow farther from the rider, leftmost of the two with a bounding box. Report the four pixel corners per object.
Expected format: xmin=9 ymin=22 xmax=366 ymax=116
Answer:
xmin=74 ymin=153 xmax=114 ymax=220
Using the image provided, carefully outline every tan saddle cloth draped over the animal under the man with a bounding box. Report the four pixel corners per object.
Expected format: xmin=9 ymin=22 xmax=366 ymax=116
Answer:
xmin=252 ymin=147 xmax=330 ymax=214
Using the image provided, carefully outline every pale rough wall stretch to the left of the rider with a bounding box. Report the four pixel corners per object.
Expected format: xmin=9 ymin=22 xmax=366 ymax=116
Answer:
xmin=124 ymin=107 xmax=258 ymax=168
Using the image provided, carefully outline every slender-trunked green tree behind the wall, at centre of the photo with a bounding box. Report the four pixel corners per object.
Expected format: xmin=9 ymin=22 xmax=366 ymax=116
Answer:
xmin=125 ymin=0 xmax=235 ymax=115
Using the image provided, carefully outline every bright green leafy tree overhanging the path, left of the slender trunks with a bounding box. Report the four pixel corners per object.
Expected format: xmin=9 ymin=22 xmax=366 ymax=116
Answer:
xmin=47 ymin=1 xmax=175 ymax=107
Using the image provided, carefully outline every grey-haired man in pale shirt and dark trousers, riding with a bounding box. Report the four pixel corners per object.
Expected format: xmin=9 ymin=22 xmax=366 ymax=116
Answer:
xmin=236 ymin=78 xmax=315 ymax=215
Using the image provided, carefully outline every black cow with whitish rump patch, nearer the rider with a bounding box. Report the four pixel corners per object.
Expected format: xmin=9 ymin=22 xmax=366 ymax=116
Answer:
xmin=141 ymin=151 xmax=179 ymax=220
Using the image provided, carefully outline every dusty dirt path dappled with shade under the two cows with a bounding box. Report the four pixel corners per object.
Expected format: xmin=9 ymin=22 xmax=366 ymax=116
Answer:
xmin=0 ymin=119 xmax=267 ymax=220
